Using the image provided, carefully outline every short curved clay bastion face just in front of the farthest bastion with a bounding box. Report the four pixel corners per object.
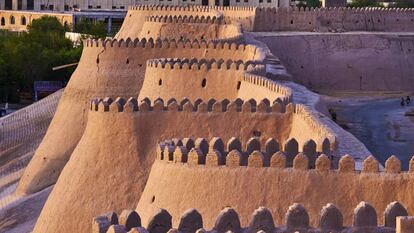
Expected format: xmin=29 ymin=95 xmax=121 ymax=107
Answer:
xmin=139 ymin=21 xmax=242 ymax=41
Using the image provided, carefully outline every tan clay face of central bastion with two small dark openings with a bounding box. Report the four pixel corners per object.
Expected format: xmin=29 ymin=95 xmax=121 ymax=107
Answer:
xmin=139 ymin=62 xmax=245 ymax=101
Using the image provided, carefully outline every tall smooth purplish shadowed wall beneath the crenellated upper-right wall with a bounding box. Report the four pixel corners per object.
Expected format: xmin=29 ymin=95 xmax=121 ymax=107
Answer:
xmin=256 ymin=33 xmax=414 ymax=91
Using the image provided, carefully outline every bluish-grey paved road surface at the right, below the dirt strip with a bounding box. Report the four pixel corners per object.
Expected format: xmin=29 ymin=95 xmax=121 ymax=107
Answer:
xmin=339 ymin=99 xmax=414 ymax=170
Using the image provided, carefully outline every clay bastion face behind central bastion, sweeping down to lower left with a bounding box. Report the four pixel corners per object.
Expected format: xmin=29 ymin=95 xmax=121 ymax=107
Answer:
xmin=17 ymin=40 xmax=263 ymax=195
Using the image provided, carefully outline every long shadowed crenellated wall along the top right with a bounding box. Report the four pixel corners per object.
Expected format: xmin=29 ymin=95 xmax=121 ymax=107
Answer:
xmin=254 ymin=8 xmax=414 ymax=32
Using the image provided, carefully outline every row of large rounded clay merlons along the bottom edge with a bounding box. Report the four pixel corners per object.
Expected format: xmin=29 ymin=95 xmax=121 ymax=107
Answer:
xmin=91 ymin=201 xmax=414 ymax=233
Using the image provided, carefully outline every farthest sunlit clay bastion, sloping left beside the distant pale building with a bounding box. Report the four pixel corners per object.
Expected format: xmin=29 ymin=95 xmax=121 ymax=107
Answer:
xmin=115 ymin=5 xmax=219 ymax=39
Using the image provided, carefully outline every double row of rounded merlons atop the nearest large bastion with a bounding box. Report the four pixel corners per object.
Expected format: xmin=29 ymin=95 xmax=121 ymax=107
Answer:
xmin=156 ymin=137 xmax=414 ymax=176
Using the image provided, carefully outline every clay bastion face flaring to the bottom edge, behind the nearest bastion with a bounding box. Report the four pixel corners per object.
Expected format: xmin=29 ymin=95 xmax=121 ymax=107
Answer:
xmin=33 ymin=104 xmax=291 ymax=233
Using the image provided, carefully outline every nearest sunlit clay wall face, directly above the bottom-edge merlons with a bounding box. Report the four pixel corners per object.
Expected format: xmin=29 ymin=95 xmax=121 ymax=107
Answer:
xmin=137 ymin=155 xmax=414 ymax=229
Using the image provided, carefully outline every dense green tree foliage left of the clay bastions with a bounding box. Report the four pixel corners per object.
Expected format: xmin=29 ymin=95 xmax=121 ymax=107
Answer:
xmin=0 ymin=16 xmax=82 ymax=101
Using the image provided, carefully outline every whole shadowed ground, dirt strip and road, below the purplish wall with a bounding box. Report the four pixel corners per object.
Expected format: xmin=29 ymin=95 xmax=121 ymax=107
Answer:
xmin=321 ymin=92 xmax=414 ymax=170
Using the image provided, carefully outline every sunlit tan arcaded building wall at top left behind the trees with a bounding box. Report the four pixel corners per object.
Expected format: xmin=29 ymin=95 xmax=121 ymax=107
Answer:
xmin=0 ymin=10 xmax=73 ymax=31
